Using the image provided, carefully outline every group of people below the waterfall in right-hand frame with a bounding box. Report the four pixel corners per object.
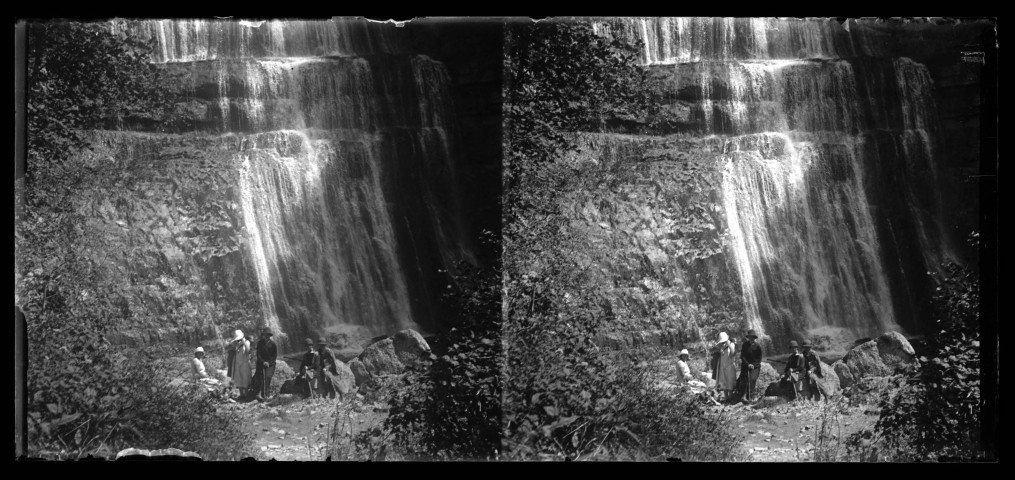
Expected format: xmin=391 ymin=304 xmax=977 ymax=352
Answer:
xmin=677 ymin=330 xmax=822 ymax=404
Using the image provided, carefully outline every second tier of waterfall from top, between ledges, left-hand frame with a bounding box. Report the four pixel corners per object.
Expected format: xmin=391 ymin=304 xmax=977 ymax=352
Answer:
xmin=167 ymin=56 xmax=454 ymax=132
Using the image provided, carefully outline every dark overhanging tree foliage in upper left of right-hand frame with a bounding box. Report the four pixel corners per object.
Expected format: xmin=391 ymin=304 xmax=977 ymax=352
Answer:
xmin=504 ymin=17 xmax=648 ymax=222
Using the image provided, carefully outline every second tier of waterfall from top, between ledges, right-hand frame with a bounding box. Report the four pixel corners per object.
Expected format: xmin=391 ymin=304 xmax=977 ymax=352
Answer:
xmin=652 ymin=58 xmax=936 ymax=135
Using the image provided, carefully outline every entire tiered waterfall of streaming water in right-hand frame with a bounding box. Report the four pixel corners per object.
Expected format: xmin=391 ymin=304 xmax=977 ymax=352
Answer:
xmin=595 ymin=18 xmax=949 ymax=347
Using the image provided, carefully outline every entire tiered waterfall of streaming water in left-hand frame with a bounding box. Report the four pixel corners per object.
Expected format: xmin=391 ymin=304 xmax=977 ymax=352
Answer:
xmin=128 ymin=20 xmax=472 ymax=345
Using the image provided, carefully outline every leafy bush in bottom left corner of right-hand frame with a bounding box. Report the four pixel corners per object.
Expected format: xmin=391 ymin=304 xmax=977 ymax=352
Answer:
xmin=504 ymin=275 xmax=740 ymax=460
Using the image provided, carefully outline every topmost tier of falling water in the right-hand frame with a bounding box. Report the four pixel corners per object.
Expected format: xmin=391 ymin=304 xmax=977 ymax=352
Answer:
xmin=594 ymin=17 xmax=886 ymax=65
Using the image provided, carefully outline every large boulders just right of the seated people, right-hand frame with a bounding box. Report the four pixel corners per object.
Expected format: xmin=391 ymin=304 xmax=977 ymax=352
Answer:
xmin=832 ymin=332 xmax=916 ymax=388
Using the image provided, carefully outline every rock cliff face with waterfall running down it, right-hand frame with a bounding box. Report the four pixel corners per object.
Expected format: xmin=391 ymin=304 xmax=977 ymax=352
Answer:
xmin=584 ymin=18 xmax=991 ymax=353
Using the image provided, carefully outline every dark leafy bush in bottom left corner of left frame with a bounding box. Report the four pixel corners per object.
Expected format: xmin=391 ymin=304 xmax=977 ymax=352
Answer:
xmin=27 ymin=334 xmax=254 ymax=460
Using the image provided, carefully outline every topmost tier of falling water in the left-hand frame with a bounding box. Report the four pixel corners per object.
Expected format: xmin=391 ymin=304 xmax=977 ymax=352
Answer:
xmin=114 ymin=18 xmax=406 ymax=63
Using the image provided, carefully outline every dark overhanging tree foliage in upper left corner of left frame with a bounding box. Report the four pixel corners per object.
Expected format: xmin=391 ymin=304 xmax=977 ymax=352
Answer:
xmin=27 ymin=21 xmax=186 ymax=201
